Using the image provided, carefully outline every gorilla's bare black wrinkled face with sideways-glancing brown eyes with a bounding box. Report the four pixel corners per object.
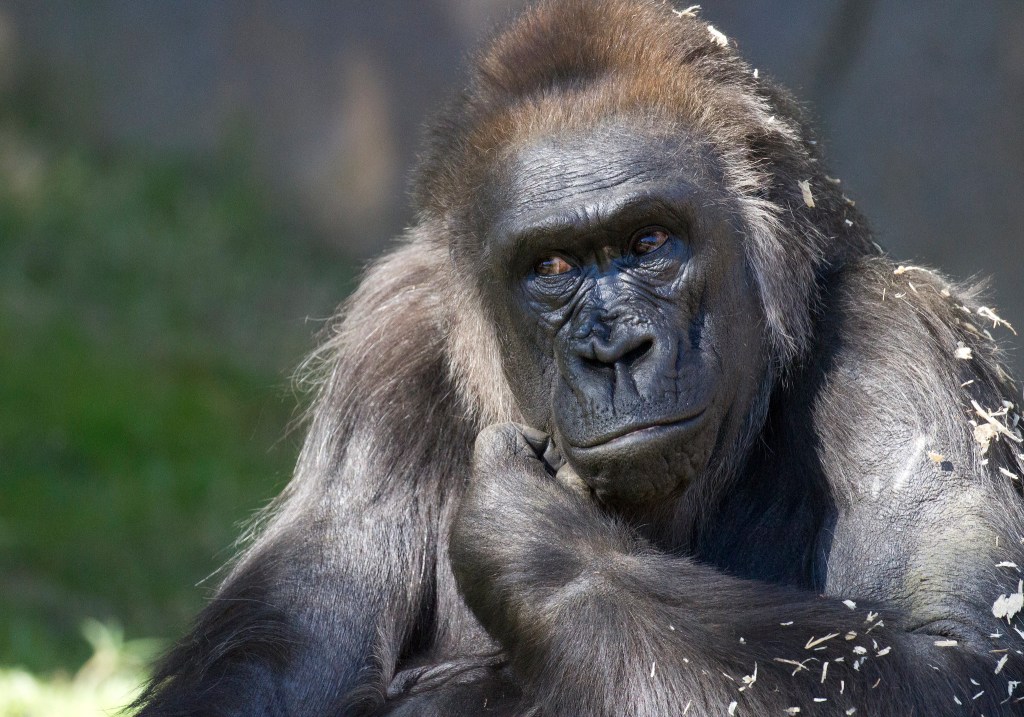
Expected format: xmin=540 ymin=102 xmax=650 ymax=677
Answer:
xmin=483 ymin=126 xmax=766 ymax=504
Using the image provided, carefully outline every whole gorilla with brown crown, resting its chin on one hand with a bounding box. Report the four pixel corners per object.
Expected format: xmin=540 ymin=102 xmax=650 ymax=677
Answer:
xmin=136 ymin=0 xmax=1024 ymax=717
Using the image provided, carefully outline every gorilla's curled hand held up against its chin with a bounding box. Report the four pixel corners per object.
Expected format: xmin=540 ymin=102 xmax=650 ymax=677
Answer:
xmin=450 ymin=423 xmax=622 ymax=650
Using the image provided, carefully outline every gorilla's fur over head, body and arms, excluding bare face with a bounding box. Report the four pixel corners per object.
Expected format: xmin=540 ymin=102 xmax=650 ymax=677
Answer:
xmin=139 ymin=0 xmax=1024 ymax=717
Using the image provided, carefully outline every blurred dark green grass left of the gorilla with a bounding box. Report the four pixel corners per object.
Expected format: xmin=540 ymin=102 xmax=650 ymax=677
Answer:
xmin=0 ymin=106 xmax=352 ymax=673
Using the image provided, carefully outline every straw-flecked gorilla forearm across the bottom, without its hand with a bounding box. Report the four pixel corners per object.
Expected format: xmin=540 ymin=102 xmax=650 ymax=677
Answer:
xmin=520 ymin=554 xmax=1006 ymax=715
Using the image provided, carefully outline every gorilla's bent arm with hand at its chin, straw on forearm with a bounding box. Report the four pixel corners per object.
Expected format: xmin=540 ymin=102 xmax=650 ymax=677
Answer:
xmin=451 ymin=424 xmax=1008 ymax=715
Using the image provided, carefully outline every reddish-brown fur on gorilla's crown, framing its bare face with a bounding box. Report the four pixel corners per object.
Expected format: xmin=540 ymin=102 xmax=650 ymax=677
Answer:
xmin=415 ymin=0 xmax=873 ymax=426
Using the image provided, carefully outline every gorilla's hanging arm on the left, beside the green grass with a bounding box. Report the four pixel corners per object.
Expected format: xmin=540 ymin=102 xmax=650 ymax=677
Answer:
xmin=138 ymin=242 xmax=473 ymax=717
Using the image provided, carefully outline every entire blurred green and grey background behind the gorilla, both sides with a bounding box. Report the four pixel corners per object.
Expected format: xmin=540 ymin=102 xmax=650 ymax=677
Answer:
xmin=0 ymin=0 xmax=1024 ymax=717
